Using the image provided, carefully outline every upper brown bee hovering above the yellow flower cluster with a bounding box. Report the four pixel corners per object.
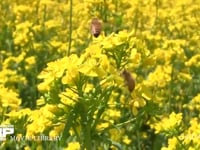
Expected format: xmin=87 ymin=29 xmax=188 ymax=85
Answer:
xmin=91 ymin=18 xmax=102 ymax=37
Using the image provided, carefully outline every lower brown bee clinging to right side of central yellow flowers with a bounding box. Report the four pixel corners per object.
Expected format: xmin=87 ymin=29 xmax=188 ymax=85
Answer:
xmin=121 ymin=70 xmax=135 ymax=92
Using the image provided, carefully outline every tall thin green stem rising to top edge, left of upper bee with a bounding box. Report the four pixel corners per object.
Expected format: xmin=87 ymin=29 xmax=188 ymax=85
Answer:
xmin=67 ymin=0 xmax=72 ymax=56
